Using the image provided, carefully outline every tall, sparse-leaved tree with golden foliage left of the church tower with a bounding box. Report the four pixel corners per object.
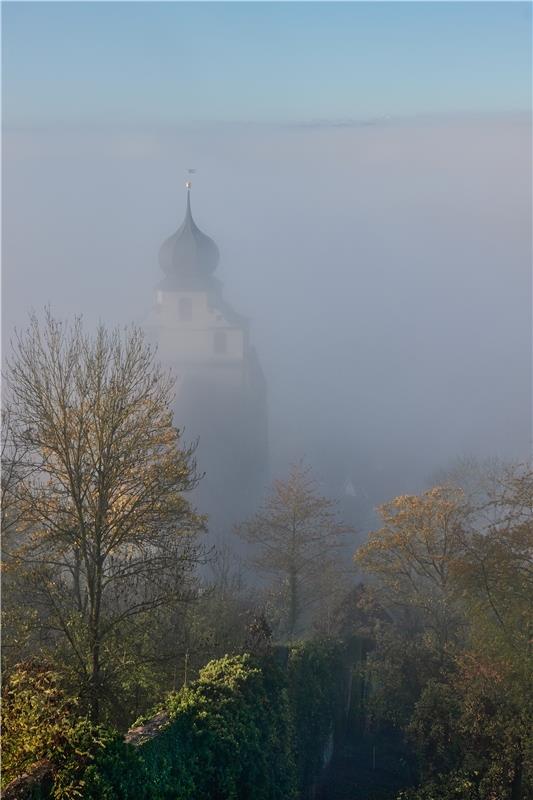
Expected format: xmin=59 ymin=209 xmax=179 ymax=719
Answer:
xmin=7 ymin=311 xmax=204 ymax=720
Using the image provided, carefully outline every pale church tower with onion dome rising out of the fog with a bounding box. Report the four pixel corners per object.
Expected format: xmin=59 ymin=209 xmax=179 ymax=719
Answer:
xmin=147 ymin=182 xmax=268 ymax=533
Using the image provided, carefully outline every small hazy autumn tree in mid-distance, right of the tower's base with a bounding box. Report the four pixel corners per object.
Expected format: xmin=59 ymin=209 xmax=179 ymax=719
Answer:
xmin=236 ymin=464 xmax=351 ymax=638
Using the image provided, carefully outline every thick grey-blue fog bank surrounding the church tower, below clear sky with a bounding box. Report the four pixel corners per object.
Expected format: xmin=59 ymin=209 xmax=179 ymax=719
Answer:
xmin=2 ymin=114 xmax=531 ymax=506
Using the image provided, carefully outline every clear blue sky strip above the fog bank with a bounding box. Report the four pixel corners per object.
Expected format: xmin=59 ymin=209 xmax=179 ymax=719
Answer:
xmin=3 ymin=2 xmax=531 ymax=126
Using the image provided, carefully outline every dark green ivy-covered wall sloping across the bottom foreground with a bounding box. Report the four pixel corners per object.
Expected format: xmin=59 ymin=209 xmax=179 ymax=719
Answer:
xmin=4 ymin=641 xmax=352 ymax=800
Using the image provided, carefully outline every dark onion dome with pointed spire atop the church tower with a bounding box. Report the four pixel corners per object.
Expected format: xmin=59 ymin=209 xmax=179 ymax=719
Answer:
xmin=159 ymin=181 xmax=219 ymax=282
